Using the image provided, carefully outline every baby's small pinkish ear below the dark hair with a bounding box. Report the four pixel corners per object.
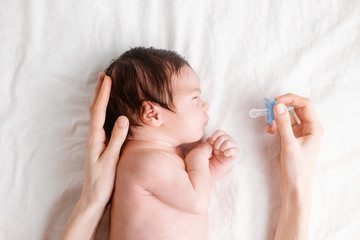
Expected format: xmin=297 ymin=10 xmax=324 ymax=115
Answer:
xmin=140 ymin=101 xmax=163 ymax=127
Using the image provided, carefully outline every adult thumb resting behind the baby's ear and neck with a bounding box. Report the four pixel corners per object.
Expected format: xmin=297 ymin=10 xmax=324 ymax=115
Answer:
xmin=104 ymin=116 xmax=129 ymax=160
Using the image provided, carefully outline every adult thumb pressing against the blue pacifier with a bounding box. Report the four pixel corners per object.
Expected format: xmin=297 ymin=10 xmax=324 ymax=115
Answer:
xmin=274 ymin=103 xmax=295 ymax=142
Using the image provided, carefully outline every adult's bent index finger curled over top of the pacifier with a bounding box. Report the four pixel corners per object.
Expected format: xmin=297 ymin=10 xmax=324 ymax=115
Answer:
xmin=275 ymin=93 xmax=319 ymax=122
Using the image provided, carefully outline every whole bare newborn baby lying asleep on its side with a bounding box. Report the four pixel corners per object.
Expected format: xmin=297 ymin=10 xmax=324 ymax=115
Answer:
xmin=104 ymin=47 xmax=239 ymax=240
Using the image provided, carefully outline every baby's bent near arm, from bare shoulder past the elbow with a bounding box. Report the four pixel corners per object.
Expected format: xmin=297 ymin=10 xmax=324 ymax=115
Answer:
xmin=135 ymin=143 xmax=212 ymax=214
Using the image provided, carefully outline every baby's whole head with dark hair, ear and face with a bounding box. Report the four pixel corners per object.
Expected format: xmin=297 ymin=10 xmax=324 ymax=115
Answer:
xmin=104 ymin=47 xmax=208 ymax=145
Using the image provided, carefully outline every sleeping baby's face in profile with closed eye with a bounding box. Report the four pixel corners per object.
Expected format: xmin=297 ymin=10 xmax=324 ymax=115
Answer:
xmin=162 ymin=66 xmax=209 ymax=144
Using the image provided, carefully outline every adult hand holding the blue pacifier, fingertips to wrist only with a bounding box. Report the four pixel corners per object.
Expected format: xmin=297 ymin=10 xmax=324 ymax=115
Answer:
xmin=267 ymin=93 xmax=324 ymax=190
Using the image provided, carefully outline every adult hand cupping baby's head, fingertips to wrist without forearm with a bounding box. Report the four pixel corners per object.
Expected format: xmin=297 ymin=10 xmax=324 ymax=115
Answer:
xmin=80 ymin=72 xmax=129 ymax=208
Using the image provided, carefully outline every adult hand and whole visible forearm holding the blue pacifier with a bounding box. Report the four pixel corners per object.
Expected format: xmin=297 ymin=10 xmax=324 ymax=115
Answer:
xmin=267 ymin=93 xmax=324 ymax=240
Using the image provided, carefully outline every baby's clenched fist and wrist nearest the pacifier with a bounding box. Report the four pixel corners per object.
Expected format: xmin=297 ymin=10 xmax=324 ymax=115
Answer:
xmin=206 ymin=130 xmax=239 ymax=186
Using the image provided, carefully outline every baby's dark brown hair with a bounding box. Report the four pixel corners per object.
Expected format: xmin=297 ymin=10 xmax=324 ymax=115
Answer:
xmin=104 ymin=47 xmax=190 ymax=143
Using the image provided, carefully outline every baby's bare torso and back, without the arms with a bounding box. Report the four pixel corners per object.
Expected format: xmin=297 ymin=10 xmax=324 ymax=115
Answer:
xmin=109 ymin=144 xmax=209 ymax=240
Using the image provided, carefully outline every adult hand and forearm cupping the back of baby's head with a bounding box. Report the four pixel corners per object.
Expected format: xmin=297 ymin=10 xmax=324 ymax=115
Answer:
xmin=60 ymin=72 xmax=129 ymax=240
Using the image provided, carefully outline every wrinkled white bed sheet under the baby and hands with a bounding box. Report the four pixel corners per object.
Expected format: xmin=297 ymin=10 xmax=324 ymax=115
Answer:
xmin=0 ymin=0 xmax=360 ymax=240
